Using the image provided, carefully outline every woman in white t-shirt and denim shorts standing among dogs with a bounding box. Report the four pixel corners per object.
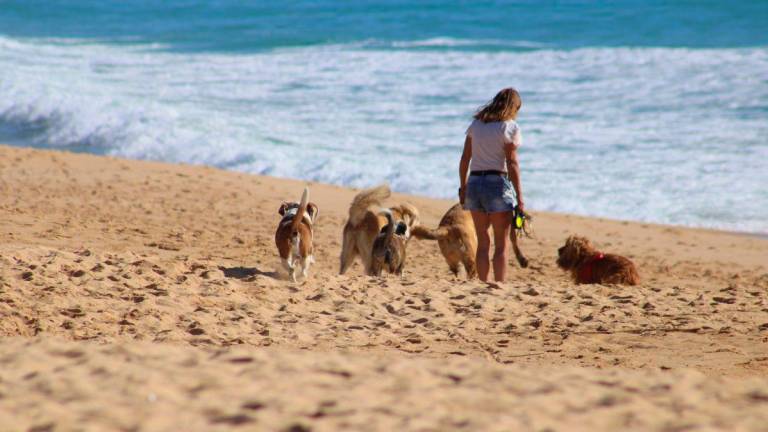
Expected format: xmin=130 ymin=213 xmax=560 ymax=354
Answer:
xmin=459 ymin=88 xmax=525 ymax=282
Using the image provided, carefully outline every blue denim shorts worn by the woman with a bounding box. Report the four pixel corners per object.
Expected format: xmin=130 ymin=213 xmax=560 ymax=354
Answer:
xmin=464 ymin=174 xmax=515 ymax=213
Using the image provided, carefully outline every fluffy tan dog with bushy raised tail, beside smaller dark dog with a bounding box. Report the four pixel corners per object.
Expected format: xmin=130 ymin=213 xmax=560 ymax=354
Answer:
xmin=339 ymin=185 xmax=419 ymax=275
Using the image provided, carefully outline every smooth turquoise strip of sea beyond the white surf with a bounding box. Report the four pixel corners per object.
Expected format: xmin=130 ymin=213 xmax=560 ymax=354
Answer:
xmin=0 ymin=0 xmax=768 ymax=52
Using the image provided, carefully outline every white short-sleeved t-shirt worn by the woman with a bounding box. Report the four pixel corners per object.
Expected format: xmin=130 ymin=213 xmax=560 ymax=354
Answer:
xmin=467 ymin=119 xmax=523 ymax=172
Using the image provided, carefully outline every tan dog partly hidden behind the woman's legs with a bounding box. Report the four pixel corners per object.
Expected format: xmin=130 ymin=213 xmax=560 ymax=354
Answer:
xmin=412 ymin=204 xmax=528 ymax=279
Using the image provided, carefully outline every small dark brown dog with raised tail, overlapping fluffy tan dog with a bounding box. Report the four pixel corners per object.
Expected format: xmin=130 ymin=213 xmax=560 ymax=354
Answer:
xmin=371 ymin=209 xmax=410 ymax=276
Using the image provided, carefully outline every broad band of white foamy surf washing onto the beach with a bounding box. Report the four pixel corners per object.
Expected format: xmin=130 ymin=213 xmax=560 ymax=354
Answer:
xmin=0 ymin=37 xmax=768 ymax=233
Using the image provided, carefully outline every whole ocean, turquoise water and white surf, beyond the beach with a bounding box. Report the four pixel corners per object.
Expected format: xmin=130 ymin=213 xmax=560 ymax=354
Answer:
xmin=0 ymin=0 xmax=768 ymax=234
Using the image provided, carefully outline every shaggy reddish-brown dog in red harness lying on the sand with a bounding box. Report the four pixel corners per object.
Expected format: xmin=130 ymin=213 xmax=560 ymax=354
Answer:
xmin=557 ymin=236 xmax=640 ymax=285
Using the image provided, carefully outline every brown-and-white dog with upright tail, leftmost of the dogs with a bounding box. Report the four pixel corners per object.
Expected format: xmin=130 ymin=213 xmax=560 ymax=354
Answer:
xmin=275 ymin=188 xmax=318 ymax=282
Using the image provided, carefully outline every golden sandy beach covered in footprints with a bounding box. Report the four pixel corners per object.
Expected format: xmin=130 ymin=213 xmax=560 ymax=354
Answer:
xmin=0 ymin=146 xmax=768 ymax=432
